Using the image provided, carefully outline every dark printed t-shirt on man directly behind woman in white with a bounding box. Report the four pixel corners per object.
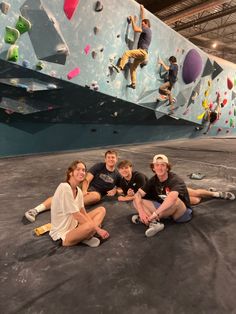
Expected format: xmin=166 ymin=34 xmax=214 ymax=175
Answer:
xmin=88 ymin=162 xmax=120 ymax=194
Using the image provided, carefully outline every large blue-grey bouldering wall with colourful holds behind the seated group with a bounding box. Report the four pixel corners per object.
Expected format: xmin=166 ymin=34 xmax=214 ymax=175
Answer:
xmin=0 ymin=0 xmax=236 ymax=155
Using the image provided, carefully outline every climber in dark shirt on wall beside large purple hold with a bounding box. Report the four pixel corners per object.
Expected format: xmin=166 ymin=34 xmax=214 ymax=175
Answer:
xmin=159 ymin=56 xmax=179 ymax=113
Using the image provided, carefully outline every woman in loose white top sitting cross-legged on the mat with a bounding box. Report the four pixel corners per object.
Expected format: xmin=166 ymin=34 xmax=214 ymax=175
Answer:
xmin=49 ymin=160 xmax=109 ymax=247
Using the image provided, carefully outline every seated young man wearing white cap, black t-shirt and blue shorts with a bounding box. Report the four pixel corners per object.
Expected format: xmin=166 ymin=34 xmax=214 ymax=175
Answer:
xmin=132 ymin=154 xmax=192 ymax=237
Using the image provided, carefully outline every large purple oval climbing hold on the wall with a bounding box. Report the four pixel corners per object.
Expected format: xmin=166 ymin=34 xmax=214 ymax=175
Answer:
xmin=183 ymin=49 xmax=202 ymax=84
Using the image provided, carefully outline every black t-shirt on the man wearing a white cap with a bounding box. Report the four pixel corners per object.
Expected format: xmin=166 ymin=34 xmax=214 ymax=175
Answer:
xmin=142 ymin=172 xmax=190 ymax=207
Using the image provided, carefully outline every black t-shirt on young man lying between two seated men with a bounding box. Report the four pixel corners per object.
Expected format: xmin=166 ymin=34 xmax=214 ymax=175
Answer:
xmin=117 ymin=171 xmax=148 ymax=195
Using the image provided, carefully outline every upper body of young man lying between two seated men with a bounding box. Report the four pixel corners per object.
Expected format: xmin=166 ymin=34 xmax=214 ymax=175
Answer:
xmin=117 ymin=160 xmax=147 ymax=202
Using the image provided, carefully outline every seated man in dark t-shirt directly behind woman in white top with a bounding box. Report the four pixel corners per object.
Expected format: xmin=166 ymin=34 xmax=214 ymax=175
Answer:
xmin=25 ymin=150 xmax=120 ymax=222
